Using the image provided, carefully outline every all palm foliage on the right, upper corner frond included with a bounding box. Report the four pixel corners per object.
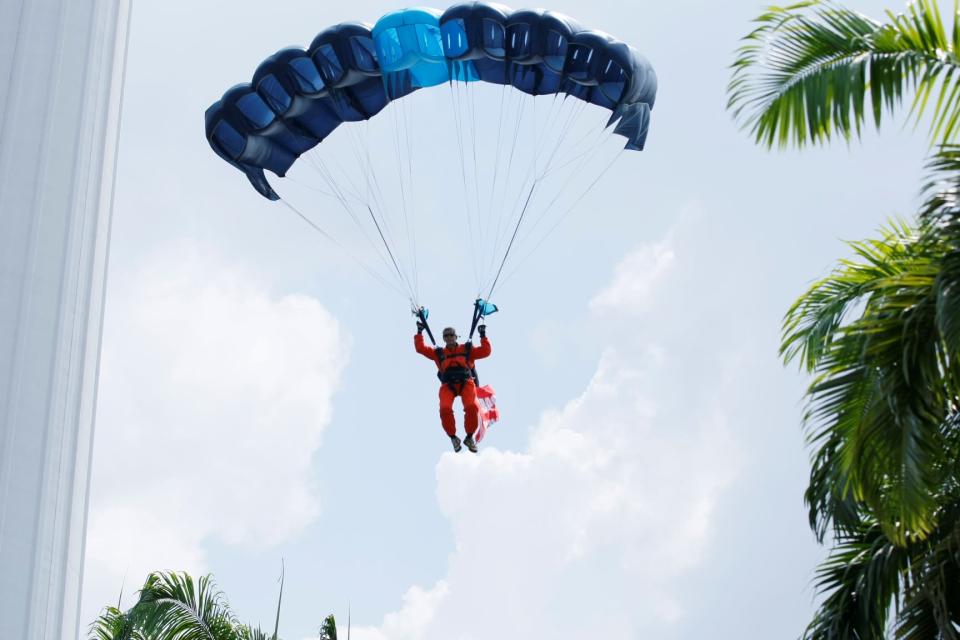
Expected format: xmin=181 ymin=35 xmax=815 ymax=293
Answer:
xmin=728 ymin=0 xmax=960 ymax=640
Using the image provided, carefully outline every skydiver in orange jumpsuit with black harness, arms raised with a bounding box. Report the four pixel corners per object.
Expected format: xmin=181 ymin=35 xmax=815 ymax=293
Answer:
xmin=413 ymin=321 xmax=491 ymax=453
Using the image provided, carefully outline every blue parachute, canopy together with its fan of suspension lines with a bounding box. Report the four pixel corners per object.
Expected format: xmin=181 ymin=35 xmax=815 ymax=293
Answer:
xmin=205 ymin=2 xmax=657 ymax=308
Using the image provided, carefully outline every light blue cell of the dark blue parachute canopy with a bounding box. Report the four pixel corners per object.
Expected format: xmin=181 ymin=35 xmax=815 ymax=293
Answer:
xmin=372 ymin=9 xmax=450 ymax=100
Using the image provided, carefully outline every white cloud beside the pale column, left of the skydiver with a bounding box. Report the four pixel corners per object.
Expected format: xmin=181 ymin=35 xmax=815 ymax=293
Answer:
xmin=84 ymin=246 xmax=348 ymax=622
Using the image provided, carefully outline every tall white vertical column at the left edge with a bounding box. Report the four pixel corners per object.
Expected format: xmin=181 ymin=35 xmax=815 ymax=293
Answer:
xmin=0 ymin=0 xmax=130 ymax=640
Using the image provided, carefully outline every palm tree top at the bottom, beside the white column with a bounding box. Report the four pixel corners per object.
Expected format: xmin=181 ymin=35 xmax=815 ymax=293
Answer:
xmin=88 ymin=572 xmax=336 ymax=640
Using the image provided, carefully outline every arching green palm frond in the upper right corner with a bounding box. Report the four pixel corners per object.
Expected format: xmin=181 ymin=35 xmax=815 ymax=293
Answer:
xmin=727 ymin=0 xmax=960 ymax=147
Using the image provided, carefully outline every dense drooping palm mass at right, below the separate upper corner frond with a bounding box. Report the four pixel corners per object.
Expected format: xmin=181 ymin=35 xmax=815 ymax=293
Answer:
xmin=781 ymin=152 xmax=960 ymax=640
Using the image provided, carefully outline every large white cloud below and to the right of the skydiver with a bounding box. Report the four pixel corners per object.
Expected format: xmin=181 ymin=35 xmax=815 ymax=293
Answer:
xmin=344 ymin=229 xmax=739 ymax=640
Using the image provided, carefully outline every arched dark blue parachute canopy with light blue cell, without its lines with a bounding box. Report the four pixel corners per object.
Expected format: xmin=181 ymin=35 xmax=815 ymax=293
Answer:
xmin=205 ymin=2 xmax=657 ymax=200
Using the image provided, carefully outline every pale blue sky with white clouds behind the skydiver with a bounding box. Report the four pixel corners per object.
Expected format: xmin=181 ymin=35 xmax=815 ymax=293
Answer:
xmin=82 ymin=0 xmax=927 ymax=640
